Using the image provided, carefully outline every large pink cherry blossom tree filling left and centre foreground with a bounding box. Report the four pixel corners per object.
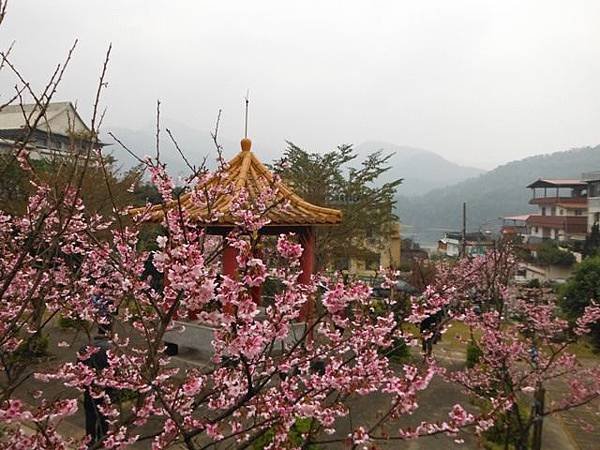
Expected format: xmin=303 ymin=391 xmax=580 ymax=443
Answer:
xmin=0 ymin=139 xmax=442 ymax=449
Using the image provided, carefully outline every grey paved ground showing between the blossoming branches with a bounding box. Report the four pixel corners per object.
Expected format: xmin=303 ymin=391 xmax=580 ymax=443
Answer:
xmin=9 ymin=318 xmax=600 ymax=450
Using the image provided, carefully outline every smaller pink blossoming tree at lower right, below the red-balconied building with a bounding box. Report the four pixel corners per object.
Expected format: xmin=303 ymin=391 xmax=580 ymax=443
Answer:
xmin=409 ymin=247 xmax=600 ymax=450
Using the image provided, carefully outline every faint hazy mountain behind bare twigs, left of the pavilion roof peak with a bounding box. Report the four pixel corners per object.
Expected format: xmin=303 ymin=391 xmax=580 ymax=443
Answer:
xmin=102 ymin=119 xmax=239 ymax=176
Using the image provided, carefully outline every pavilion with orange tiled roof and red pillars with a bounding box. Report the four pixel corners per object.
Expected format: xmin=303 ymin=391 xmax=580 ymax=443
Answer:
xmin=133 ymin=138 xmax=342 ymax=319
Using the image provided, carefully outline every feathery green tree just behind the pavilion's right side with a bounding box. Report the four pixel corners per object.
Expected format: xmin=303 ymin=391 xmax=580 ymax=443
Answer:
xmin=273 ymin=142 xmax=402 ymax=267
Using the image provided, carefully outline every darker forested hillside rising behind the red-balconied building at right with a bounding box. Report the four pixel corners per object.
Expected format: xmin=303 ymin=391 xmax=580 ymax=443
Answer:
xmin=397 ymin=145 xmax=600 ymax=242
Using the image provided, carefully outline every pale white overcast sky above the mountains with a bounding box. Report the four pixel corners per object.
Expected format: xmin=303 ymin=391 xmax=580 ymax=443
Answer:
xmin=0 ymin=0 xmax=600 ymax=168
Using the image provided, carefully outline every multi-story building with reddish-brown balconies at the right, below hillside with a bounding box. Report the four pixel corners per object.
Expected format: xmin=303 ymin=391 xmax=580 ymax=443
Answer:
xmin=526 ymin=178 xmax=588 ymax=244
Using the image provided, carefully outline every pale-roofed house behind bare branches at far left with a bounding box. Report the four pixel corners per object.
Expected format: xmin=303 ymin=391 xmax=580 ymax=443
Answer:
xmin=0 ymin=102 xmax=105 ymax=158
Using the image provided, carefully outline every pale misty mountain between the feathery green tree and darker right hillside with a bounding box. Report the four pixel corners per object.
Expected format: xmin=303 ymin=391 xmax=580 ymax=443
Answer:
xmin=354 ymin=141 xmax=484 ymax=195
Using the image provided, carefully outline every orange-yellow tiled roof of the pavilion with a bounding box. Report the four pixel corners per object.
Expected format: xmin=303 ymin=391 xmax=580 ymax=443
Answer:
xmin=136 ymin=139 xmax=342 ymax=227
